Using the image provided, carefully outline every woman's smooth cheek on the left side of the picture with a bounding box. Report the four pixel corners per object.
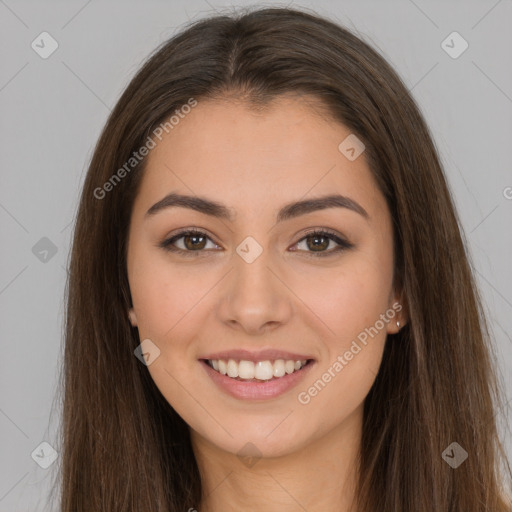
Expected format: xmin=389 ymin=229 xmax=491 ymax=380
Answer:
xmin=130 ymin=251 xmax=210 ymax=421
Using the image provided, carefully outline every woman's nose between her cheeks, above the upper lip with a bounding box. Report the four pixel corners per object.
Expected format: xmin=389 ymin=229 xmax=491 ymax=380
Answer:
xmin=217 ymin=244 xmax=293 ymax=336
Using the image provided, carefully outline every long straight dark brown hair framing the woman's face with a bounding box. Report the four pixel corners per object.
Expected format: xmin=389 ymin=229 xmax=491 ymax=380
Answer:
xmin=54 ymin=8 xmax=510 ymax=512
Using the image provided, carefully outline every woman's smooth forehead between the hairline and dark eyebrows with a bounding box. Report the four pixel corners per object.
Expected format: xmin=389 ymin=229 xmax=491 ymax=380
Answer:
xmin=132 ymin=97 xmax=385 ymax=222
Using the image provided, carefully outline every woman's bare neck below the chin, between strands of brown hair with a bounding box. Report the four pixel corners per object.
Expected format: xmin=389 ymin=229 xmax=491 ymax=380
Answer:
xmin=191 ymin=407 xmax=362 ymax=512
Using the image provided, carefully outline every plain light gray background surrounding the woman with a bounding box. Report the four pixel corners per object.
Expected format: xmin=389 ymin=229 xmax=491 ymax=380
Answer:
xmin=0 ymin=0 xmax=512 ymax=512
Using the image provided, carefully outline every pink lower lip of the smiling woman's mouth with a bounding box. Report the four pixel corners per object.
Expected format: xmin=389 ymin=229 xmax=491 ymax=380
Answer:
xmin=200 ymin=360 xmax=315 ymax=400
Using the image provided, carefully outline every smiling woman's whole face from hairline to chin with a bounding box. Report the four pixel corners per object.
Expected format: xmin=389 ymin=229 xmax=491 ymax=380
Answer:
xmin=128 ymin=97 xmax=402 ymax=456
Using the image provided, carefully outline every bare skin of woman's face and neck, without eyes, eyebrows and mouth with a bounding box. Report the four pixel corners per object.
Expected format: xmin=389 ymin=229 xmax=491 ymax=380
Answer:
xmin=127 ymin=96 xmax=406 ymax=512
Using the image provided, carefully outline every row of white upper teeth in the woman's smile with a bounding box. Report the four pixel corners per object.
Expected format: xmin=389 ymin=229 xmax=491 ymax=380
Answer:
xmin=208 ymin=359 xmax=307 ymax=380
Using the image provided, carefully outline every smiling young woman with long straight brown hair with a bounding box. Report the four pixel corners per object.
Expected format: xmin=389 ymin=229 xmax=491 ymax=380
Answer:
xmin=57 ymin=5 xmax=510 ymax=512
